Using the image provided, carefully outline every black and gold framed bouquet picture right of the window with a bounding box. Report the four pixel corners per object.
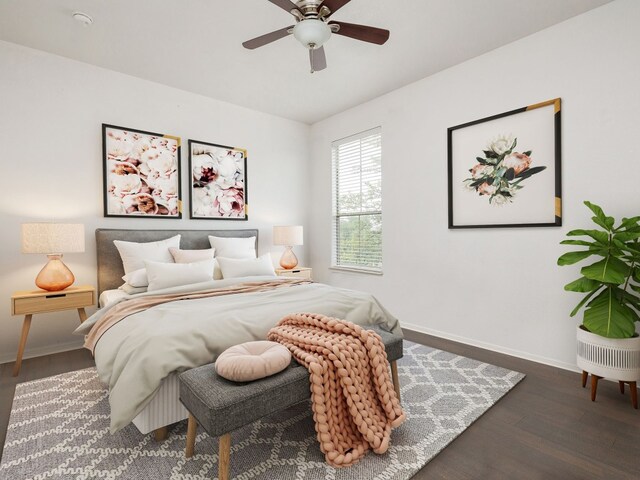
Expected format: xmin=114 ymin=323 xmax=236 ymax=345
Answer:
xmin=447 ymin=98 xmax=562 ymax=228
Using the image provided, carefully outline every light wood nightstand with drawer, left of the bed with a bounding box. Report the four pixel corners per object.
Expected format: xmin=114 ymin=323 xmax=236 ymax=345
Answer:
xmin=11 ymin=285 xmax=96 ymax=377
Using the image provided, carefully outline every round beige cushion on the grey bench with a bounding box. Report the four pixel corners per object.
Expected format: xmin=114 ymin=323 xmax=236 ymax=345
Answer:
xmin=216 ymin=340 xmax=291 ymax=382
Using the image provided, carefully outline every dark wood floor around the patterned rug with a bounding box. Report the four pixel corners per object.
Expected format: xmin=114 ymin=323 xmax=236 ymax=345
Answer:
xmin=0 ymin=331 xmax=640 ymax=480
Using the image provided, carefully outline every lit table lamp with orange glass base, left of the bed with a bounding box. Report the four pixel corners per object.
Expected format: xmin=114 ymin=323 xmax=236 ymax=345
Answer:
xmin=22 ymin=223 xmax=84 ymax=292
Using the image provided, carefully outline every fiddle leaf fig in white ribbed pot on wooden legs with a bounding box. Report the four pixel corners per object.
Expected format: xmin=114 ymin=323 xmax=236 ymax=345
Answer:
xmin=558 ymin=201 xmax=640 ymax=408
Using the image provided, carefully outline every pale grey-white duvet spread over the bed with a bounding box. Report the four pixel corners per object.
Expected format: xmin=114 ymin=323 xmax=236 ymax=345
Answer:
xmin=76 ymin=277 xmax=401 ymax=431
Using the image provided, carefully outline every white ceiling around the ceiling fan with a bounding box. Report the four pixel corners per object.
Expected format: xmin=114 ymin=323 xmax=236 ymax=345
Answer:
xmin=0 ymin=0 xmax=610 ymax=123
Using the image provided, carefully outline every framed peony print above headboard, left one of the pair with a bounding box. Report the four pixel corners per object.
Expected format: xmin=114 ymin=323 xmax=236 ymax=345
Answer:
xmin=102 ymin=124 xmax=182 ymax=218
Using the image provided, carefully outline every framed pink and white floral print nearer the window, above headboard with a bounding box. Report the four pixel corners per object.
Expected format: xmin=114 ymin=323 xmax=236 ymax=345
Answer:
xmin=189 ymin=140 xmax=248 ymax=220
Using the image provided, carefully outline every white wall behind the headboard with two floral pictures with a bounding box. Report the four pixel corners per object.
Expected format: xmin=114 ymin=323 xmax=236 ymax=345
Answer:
xmin=0 ymin=42 xmax=309 ymax=362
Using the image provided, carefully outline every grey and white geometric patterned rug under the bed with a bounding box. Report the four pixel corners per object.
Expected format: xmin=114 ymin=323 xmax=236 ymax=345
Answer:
xmin=0 ymin=341 xmax=524 ymax=480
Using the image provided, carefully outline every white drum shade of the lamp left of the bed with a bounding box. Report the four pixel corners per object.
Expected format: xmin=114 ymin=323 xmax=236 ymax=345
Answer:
xmin=22 ymin=223 xmax=84 ymax=254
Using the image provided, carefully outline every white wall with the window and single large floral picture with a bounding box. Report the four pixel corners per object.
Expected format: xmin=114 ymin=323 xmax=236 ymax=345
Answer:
xmin=310 ymin=0 xmax=640 ymax=368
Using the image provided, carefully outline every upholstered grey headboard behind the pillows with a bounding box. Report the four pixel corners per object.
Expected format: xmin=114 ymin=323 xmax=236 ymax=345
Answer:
xmin=96 ymin=228 xmax=258 ymax=294
